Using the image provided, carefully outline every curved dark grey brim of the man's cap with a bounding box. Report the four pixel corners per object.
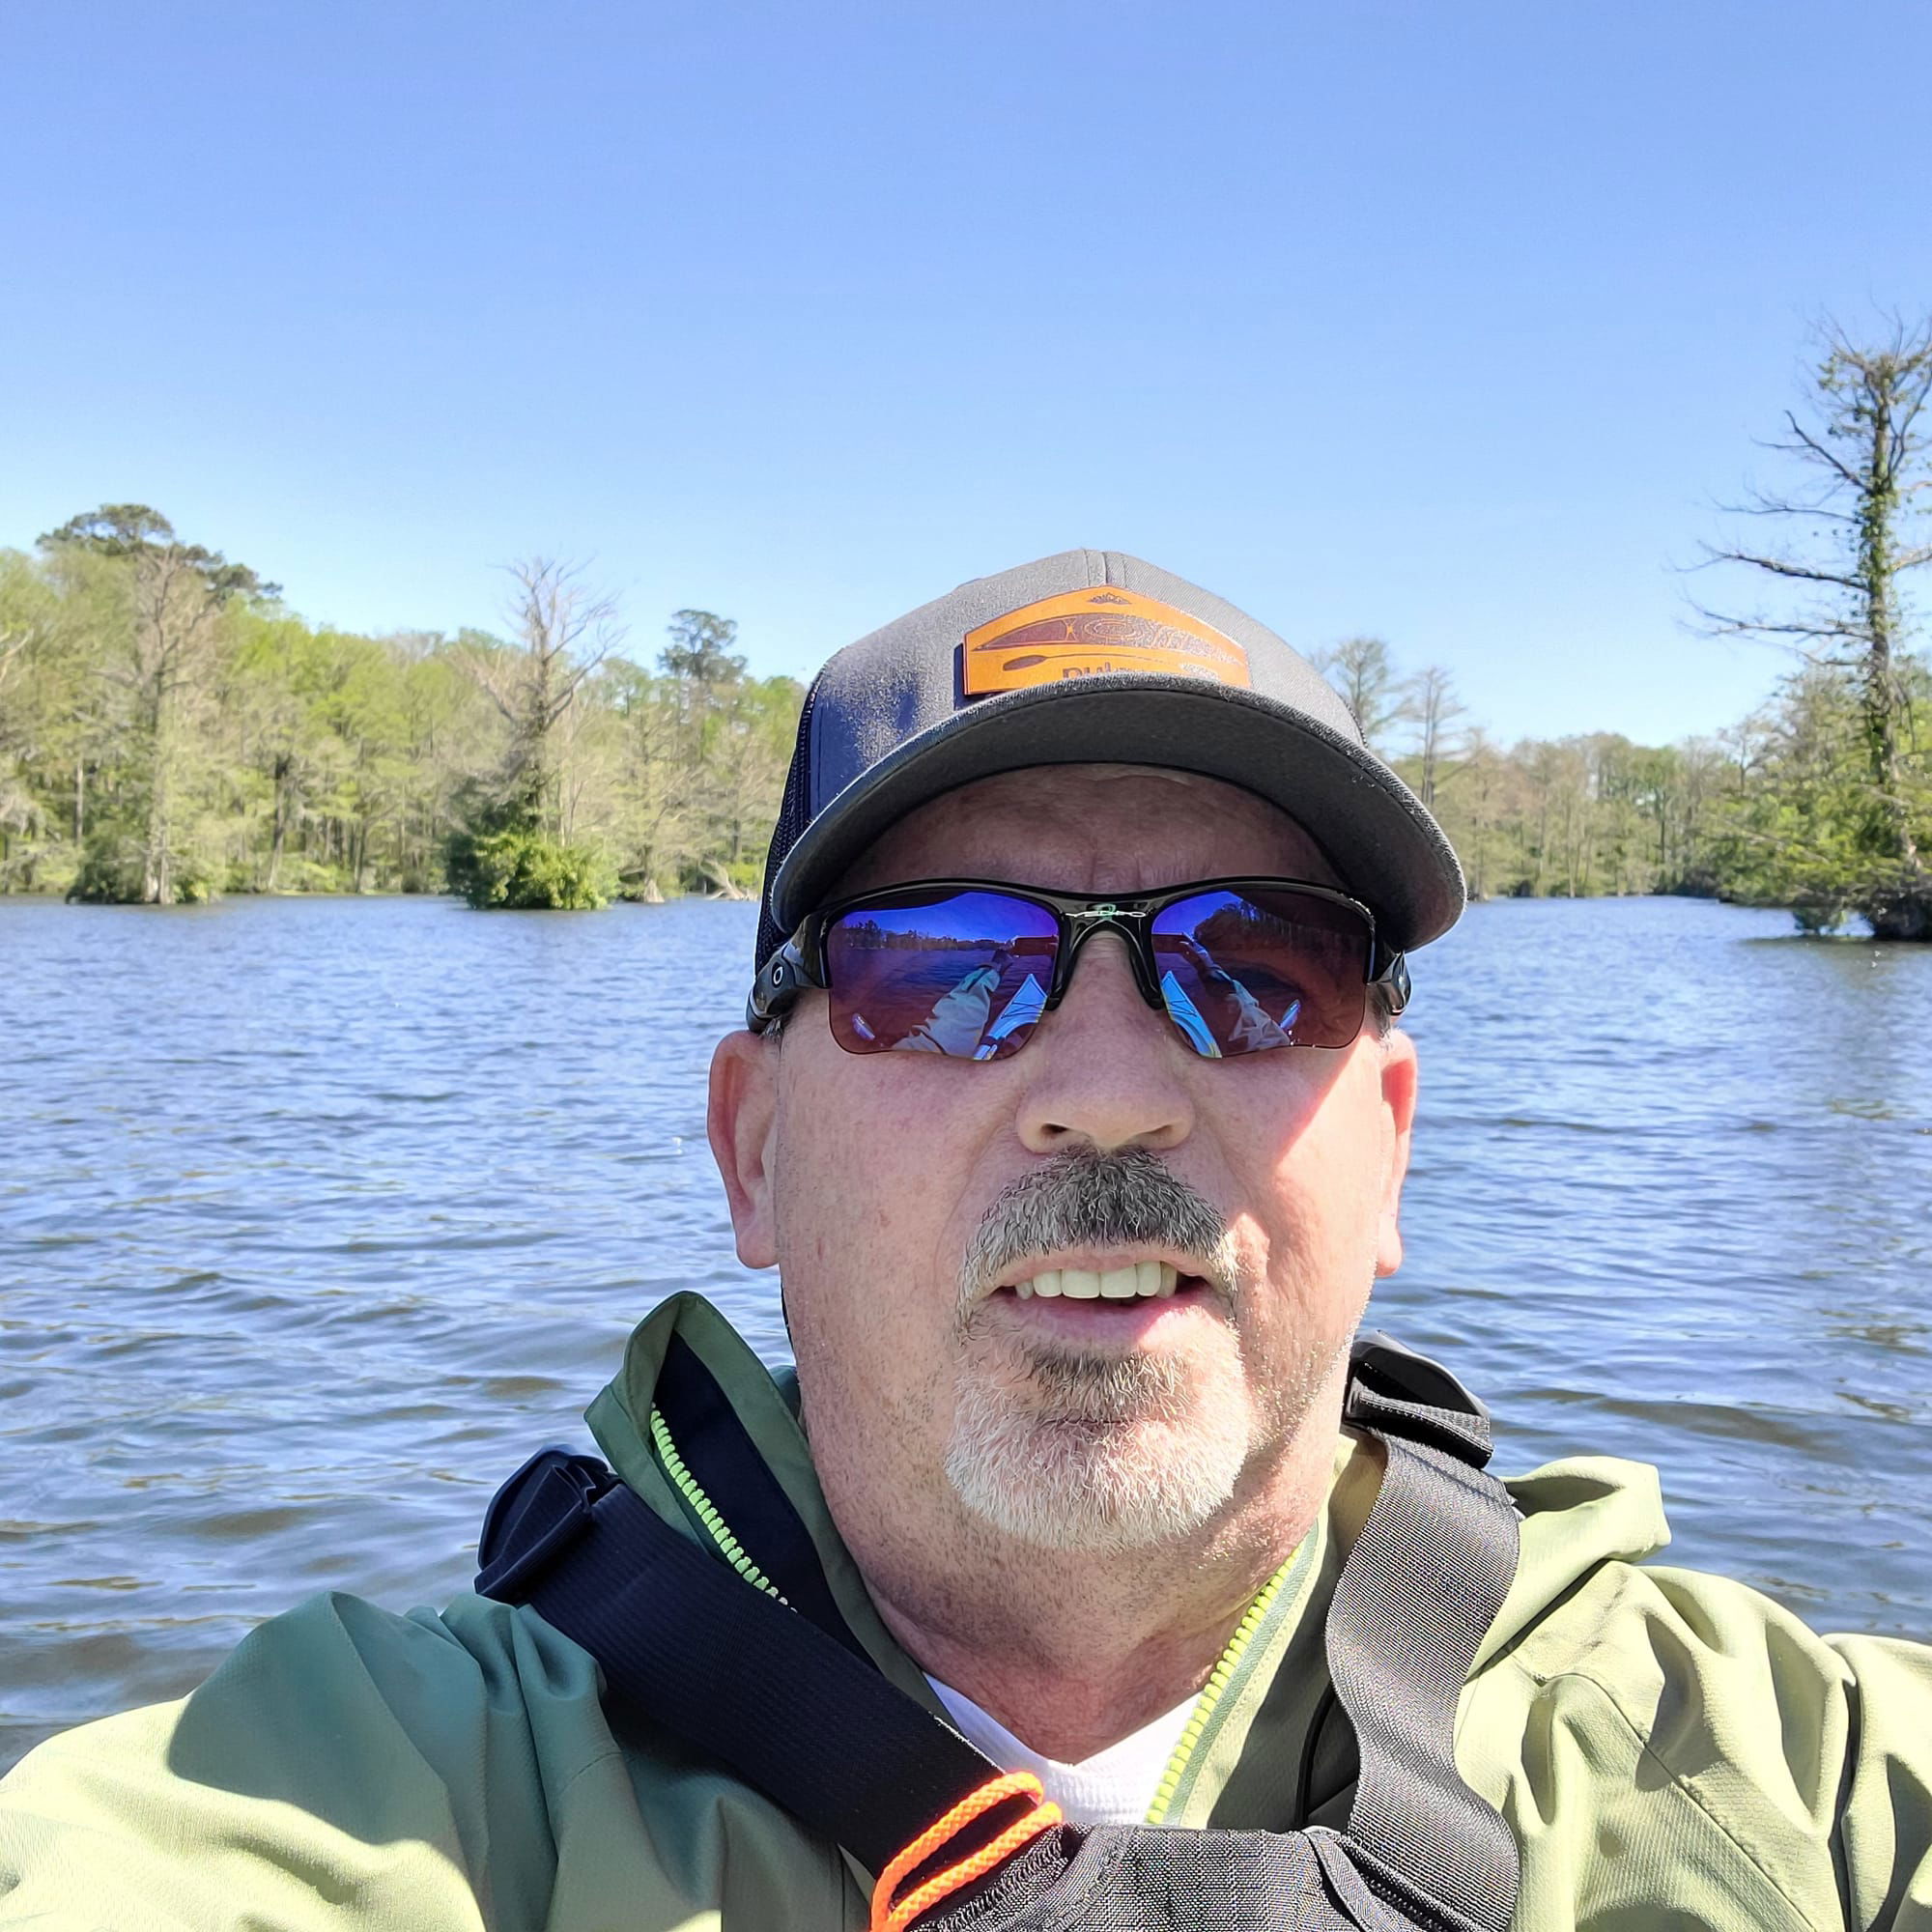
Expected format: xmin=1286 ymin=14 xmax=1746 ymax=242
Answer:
xmin=771 ymin=674 xmax=1464 ymax=951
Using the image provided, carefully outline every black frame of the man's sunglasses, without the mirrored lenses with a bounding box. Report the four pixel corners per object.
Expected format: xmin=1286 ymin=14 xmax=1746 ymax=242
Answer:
xmin=744 ymin=875 xmax=1408 ymax=1051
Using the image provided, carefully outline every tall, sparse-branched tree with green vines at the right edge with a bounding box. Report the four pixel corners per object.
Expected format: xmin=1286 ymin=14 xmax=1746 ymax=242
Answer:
xmin=1696 ymin=319 xmax=1932 ymax=939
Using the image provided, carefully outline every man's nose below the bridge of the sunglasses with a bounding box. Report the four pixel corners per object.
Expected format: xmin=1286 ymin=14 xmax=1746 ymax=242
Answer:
xmin=1012 ymin=933 xmax=1194 ymax=1153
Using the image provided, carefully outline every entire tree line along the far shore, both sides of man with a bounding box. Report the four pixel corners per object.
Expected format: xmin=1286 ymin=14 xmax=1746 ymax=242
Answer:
xmin=0 ymin=313 xmax=1932 ymax=939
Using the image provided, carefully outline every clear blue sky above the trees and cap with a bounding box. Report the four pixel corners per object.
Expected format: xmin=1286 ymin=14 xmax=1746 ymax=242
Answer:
xmin=0 ymin=0 xmax=1932 ymax=740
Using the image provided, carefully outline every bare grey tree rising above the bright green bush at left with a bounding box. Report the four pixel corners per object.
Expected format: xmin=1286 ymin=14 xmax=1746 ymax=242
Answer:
xmin=458 ymin=556 xmax=624 ymax=838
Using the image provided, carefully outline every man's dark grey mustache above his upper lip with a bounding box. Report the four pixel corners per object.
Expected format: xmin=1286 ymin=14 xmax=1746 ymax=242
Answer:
xmin=960 ymin=1148 xmax=1236 ymax=1312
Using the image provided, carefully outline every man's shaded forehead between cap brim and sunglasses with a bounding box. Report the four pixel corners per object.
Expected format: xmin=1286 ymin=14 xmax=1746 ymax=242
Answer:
xmin=838 ymin=765 xmax=1345 ymax=895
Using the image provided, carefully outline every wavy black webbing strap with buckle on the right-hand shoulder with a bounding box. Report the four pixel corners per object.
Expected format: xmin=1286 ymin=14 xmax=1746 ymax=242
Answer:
xmin=1327 ymin=1335 xmax=1520 ymax=1932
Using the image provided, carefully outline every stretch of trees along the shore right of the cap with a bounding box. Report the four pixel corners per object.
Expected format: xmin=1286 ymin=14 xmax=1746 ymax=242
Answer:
xmin=1360 ymin=319 xmax=1932 ymax=941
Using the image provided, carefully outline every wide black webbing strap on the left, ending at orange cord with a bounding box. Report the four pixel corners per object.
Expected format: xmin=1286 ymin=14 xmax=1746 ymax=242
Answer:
xmin=477 ymin=1451 xmax=999 ymax=1872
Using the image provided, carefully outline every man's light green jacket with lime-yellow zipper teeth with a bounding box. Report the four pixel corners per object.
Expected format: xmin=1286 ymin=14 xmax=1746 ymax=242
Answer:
xmin=0 ymin=1296 xmax=1932 ymax=1932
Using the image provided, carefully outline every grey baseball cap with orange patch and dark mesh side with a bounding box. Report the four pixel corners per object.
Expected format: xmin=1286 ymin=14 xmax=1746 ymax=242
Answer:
xmin=757 ymin=551 xmax=1464 ymax=968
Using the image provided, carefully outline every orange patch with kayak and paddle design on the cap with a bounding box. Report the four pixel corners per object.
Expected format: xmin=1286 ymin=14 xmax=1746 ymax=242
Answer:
xmin=960 ymin=589 xmax=1248 ymax=697
